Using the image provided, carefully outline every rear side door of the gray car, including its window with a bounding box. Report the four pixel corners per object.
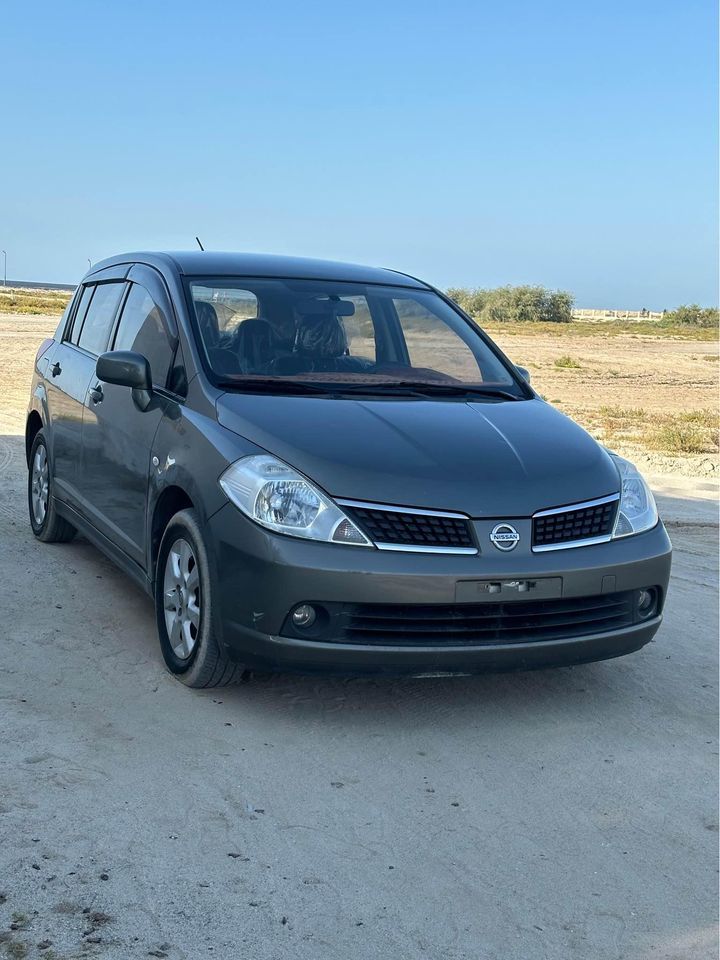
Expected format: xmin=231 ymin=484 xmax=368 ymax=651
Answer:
xmin=46 ymin=268 xmax=127 ymax=508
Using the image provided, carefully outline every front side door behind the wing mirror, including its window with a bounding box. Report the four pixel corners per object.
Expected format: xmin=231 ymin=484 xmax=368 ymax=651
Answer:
xmin=80 ymin=265 xmax=183 ymax=568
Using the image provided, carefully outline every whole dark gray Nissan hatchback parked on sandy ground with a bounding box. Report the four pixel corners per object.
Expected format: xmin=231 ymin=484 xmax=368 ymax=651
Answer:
xmin=26 ymin=251 xmax=671 ymax=687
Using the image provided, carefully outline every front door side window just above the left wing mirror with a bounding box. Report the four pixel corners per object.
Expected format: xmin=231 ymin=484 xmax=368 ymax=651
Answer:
xmin=113 ymin=283 xmax=175 ymax=387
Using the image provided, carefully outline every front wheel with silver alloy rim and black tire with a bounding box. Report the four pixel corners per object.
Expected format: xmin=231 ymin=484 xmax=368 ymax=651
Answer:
xmin=155 ymin=510 xmax=246 ymax=688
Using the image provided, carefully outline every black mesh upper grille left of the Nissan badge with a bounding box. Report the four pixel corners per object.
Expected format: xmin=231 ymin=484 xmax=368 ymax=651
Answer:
xmin=341 ymin=501 xmax=475 ymax=549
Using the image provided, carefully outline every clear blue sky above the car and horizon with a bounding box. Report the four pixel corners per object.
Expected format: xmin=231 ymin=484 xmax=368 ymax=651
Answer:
xmin=0 ymin=0 xmax=718 ymax=309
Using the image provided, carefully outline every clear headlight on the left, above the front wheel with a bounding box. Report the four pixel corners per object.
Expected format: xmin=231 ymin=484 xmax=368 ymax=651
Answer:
xmin=220 ymin=454 xmax=372 ymax=547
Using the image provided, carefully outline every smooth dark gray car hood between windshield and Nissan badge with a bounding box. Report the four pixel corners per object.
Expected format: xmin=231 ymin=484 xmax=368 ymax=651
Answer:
xmin=217 ymin=393 xmax=620 ymax=518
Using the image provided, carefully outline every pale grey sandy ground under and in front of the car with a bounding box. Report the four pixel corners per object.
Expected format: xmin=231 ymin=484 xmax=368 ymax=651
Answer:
xmin=0 ymin=316 xmax=718 ymax=960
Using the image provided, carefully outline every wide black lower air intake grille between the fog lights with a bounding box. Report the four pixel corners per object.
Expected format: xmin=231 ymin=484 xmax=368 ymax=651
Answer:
xmin=333 ymin=591 xmax=634 ymax=646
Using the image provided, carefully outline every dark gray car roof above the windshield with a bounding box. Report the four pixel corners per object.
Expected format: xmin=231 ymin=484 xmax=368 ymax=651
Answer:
xmin=88 ymin=250 xmax=428 ymax=289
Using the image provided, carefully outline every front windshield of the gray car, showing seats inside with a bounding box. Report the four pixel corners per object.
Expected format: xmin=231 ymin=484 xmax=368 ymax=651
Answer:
xmin=189 ymin=277 xmax=527 ymax=399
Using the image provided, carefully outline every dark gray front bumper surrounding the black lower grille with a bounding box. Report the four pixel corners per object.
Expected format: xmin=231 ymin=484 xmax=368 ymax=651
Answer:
xmin=207 ymin=504 xmax=672 ymax=675
